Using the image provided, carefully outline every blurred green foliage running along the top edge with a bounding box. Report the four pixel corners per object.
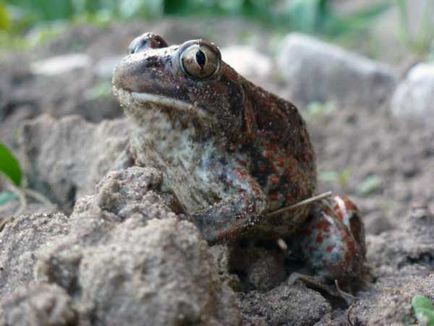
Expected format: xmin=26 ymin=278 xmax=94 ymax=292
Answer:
xmin=4 ymin=0 xmax=389 ymax=37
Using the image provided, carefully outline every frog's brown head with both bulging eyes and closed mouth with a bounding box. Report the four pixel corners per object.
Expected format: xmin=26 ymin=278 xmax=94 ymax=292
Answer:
xmin=113 ymin=33 xmax=251 ymax=141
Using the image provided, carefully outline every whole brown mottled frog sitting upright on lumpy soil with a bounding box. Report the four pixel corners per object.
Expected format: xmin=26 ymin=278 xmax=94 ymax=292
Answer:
xmin=112 ymin=32 xmax=365 ymax=279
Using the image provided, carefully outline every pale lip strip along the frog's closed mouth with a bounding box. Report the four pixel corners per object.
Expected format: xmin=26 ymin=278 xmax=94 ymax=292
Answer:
xmin=114 ymin=88 xmax=210 ymax=121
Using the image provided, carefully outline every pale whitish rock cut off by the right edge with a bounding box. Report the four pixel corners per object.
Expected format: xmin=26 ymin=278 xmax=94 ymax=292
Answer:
xmin=390 ymin=63 xmax=434 ymax=122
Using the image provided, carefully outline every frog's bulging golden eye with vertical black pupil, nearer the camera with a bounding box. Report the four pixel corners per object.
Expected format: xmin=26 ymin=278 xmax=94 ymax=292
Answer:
xmin=181 ymin=44 xmax=220 ymax=79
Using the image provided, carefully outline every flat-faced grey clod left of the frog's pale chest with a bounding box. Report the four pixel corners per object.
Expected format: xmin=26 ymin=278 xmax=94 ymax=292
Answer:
xmin=20 ymin=115 xmax=129 ymax=209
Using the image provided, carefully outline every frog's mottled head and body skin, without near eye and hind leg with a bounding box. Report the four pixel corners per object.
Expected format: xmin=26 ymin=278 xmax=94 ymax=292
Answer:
xmin=113 ymin=33 xmax=316 ymax=242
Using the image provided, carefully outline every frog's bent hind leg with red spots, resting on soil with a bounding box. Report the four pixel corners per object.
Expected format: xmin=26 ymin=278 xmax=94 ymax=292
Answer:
xmin=299 ymin=196 xmax=366 ymax=289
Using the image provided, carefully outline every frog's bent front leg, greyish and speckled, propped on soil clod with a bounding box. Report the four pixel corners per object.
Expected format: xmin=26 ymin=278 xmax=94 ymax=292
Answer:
xmin=192 ymin=169 xmax=267 ymax=243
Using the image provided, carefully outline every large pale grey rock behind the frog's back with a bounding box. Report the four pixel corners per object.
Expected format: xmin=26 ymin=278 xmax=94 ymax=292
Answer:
xmin=278 ymin=33 xmax=398 ymax=110
